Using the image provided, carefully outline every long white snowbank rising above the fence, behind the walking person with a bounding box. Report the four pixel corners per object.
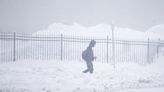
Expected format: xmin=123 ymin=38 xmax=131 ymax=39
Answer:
xmin=34 ymin=23 xmax=163 ymax=41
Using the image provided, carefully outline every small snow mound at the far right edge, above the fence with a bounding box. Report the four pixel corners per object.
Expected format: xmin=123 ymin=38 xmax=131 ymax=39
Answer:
xmin=147 ymin=24 xmax=164 ymax=39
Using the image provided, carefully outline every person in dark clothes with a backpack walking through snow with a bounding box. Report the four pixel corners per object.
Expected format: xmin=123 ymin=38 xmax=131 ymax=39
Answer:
xmin=82 ymin=40 xmax=96 ymax=73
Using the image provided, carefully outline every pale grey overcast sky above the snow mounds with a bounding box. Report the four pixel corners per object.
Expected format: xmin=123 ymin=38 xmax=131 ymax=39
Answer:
xmin=0 ymin=0 xmax=164 ymax=33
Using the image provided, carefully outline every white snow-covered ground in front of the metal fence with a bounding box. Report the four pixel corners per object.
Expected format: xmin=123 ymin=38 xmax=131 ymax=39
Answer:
xmin=0 ymin=57 xmax=164 ymax=92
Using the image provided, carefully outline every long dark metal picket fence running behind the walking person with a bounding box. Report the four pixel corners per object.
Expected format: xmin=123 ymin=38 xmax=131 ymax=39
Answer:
xmin=0 ymin=33 xmax=163 ymax=64
